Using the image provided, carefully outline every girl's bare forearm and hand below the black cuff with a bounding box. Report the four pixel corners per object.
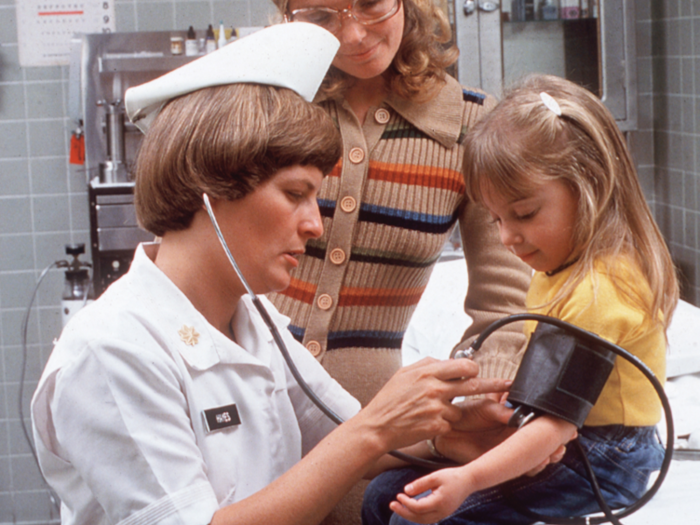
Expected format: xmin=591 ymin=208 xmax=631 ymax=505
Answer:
xmin=391 ymin=416 xmax=576 ymax=523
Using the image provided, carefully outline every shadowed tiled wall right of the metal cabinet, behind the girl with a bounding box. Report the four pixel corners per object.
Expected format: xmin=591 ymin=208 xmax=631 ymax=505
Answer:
xmin=636 ymin=0 xmax=700 ymax=305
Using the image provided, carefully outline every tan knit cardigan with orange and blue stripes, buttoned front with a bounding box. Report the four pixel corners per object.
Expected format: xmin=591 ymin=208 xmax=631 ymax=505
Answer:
xmin=271 ymin=73 xmax=530 ymax=404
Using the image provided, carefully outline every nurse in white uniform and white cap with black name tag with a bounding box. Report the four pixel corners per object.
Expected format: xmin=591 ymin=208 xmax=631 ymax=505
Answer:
xmin=32 ymin=23 xmax=508 ymax=525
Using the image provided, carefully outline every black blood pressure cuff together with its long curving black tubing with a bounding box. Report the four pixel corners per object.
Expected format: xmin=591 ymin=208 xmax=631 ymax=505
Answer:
xmin=455 ymin=314 xmax=674 ymax=525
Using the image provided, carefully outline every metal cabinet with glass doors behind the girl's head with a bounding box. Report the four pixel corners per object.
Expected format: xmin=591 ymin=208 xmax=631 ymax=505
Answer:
xmin=448 ymin=0 xmax=637 ymax=131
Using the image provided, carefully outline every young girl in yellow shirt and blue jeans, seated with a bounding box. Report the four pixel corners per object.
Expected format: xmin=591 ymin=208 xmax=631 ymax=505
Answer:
xmin=366 ymin=72 xmax=678 ymax=525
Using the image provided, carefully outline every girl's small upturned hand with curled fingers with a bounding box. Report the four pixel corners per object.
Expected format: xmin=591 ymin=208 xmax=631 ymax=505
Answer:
xmin=389 ymin=468 xmax=471 ymax=523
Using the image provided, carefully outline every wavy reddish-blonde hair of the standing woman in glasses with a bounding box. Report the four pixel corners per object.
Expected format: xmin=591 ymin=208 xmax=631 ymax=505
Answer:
xmin=273 ymin=0 xmax=459 ymax=102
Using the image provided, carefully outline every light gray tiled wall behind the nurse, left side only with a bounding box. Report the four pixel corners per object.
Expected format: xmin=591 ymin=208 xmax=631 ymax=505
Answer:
xmin=0 ymin=0 xmax=274 ymax=525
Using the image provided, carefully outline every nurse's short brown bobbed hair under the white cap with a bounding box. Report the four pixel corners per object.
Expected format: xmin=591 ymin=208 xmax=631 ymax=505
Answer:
xmin=134 ymin=84 xmax=342 ymax=236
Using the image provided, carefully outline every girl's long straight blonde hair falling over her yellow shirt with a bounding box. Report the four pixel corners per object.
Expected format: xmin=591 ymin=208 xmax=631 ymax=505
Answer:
xmin=464 ymin=75 xmax=679 ymax=328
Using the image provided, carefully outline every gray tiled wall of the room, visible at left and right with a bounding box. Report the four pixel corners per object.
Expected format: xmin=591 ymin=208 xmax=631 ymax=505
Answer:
xmin=0 ymin=0 xmax=700 ymax=524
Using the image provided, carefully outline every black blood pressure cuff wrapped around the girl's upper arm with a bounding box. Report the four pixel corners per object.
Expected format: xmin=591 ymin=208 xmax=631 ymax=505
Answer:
xmin=508 ymin=322 xmax=617 ymax=429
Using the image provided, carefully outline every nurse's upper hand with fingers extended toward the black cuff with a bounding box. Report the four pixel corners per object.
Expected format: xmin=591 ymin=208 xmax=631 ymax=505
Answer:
xmin=356 ymin=358 xmax=510 ymax=451
